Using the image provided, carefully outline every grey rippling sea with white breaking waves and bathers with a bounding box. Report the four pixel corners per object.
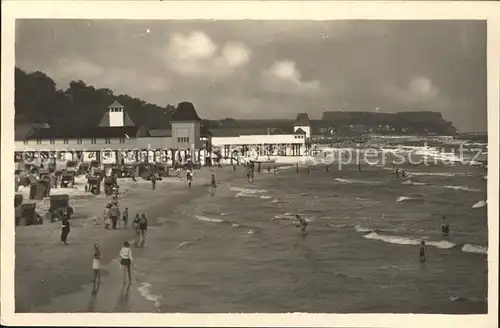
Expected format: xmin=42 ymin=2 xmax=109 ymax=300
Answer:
xmin=128 ymin=140 xmax=488 ymax=314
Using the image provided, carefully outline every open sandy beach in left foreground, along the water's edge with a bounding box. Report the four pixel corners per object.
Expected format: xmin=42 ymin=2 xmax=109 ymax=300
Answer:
xmin=15 ymin=168 xmax=233 ymax=312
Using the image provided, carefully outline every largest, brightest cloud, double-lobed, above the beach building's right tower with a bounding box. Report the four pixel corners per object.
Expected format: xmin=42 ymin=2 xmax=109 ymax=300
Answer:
xmin=166 ymin=31 xmax=251 ymax=78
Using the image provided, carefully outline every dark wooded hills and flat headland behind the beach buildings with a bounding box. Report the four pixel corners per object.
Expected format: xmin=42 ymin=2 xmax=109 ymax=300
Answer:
xmin=15 ymin=67 xmax=458 ymax=135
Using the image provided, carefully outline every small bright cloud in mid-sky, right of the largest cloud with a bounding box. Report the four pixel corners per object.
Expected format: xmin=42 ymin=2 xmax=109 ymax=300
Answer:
xmin=262 ymin=60 xmax=320 ymax=93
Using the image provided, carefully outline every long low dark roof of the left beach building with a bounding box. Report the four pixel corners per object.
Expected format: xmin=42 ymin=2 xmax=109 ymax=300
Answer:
xmin=29 ymin=126 xmax=149 ymax=139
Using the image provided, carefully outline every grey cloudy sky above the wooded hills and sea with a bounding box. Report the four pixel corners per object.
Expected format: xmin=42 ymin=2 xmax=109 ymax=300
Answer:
xmin=15 ymin=19 xmax=487 ymax=132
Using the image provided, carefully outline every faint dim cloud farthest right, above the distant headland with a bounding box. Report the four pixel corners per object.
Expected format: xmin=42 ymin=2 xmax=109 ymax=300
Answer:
xmin=382 ymin=75 xmax=447 ymax=107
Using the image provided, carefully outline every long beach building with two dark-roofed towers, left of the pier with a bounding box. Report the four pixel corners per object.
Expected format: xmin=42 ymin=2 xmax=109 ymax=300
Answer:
xmin=15 ymin=101 xmax=211 ymax=165
